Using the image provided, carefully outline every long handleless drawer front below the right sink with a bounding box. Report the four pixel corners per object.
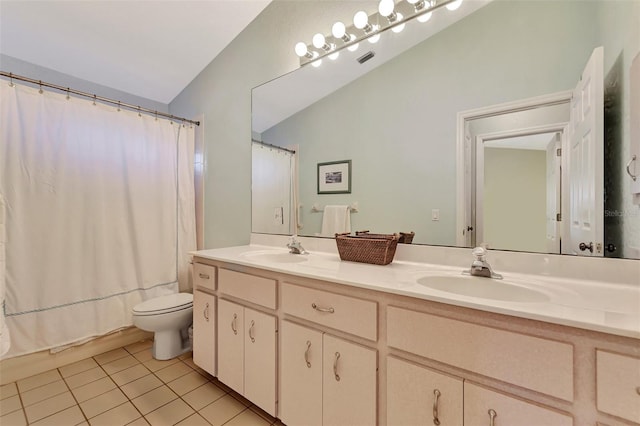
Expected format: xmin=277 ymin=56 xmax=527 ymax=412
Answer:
xmin=387 ymin=306 xmax=573 ymax=401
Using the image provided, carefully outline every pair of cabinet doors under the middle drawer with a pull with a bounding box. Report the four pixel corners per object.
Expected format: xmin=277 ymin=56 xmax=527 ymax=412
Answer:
xmin=279 ymin=320 xmax=377 ymax=426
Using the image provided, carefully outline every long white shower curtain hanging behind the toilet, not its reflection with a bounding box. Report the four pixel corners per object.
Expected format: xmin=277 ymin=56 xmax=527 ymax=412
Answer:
xmin=0 ymin=82 xmax=196 ymax=358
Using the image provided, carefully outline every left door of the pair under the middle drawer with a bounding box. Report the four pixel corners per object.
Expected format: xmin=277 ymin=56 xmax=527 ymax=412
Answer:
xmin=279 ymin=321 xmax=322 ymax=426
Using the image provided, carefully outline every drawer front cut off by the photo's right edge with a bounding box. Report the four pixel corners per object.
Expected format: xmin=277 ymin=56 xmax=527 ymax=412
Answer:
xmin=596 ymin=350 xmax=640 ymax=423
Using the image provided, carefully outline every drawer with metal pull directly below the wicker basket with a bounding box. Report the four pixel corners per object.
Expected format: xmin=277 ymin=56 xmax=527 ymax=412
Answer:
xmin=282 ymin=283 xmax=378 ymax=341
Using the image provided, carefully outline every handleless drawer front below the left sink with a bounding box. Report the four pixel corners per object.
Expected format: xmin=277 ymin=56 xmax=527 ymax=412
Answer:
xmin=218 ymin=268 xmax=276 ymax=309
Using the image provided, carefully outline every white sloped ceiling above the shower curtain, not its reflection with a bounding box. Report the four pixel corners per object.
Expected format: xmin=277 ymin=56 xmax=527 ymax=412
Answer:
xmin=0 ymin=0 xmax=271 ymax=104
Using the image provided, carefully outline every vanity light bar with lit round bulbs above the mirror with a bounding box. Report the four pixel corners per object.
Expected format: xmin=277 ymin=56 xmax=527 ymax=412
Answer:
xmin=295 ymin=0 xmax=463 ymax=66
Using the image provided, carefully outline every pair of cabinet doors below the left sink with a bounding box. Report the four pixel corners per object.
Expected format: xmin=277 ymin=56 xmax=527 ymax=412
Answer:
xmin=218 ymin=299 xmax=277 ymax=416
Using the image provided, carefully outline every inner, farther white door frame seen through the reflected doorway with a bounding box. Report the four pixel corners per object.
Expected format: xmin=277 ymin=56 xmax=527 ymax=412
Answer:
xmin=472 ymin=121 xmax=569 ymax=250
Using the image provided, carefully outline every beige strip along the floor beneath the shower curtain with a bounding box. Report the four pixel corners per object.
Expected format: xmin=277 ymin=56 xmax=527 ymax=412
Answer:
xmin=0 ymin=327 xmax=153 ymax=385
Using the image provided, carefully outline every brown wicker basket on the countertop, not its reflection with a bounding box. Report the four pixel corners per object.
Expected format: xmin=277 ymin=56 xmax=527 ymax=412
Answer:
xmin=336 ymin=232 xmax=399 ymax=265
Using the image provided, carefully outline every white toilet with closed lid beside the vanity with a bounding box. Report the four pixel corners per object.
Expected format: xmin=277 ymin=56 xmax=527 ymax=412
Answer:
xmin=132 ymin=293 xmax=193 ymax=360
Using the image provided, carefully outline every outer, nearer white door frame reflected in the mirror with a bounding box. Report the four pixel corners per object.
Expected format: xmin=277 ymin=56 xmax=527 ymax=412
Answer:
xmin=456 ymin=90 xmax=573 ymax=247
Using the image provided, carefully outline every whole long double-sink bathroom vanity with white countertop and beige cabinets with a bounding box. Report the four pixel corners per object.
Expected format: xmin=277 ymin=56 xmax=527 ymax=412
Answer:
xmin=193 ymin=238 xmax=640 ymax=426
